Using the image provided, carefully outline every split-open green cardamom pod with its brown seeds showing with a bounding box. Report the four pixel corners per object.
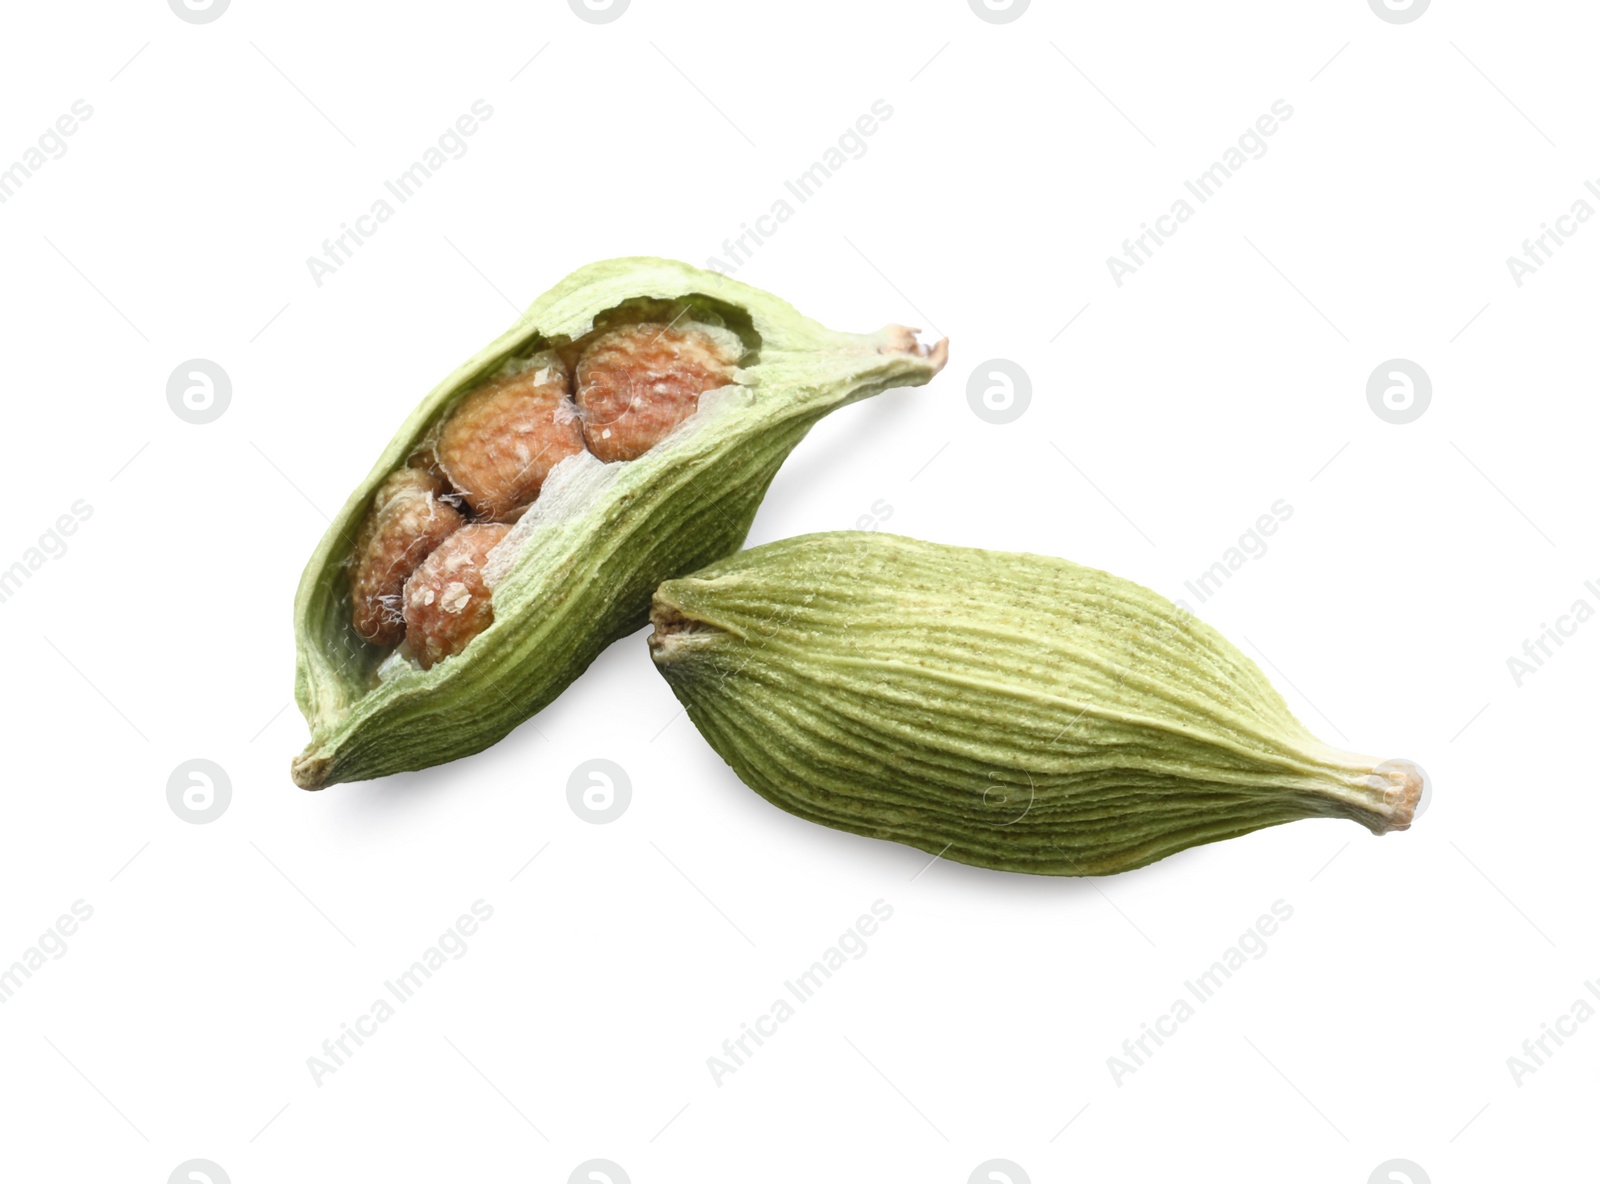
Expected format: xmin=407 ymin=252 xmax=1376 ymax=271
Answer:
xmin=291 ymin=259 xmax=946 ymax=789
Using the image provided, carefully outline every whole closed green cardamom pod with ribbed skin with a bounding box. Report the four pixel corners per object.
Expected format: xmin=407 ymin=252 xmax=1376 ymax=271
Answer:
xmin=650 ymin=531 xmax=1424 ymax=875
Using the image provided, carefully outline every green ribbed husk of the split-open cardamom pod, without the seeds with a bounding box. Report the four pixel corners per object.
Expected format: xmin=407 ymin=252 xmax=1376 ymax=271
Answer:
xmin=291 ymin=259 xmax=946 ymax=789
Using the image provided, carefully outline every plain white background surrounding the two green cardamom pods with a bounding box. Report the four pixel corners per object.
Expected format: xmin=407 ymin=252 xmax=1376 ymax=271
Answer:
xmin=0 ymin=0 xmax=1600 ymax=1184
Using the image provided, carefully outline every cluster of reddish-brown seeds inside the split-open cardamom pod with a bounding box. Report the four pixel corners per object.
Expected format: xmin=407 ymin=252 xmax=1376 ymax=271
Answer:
xmin=350 ymin=320 xmax=742 ymax=669
